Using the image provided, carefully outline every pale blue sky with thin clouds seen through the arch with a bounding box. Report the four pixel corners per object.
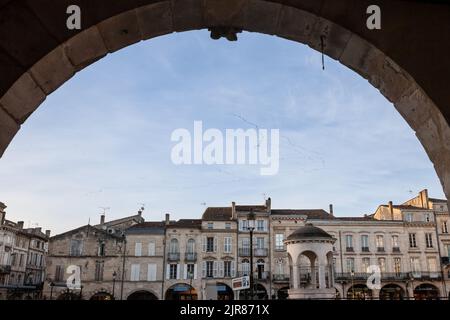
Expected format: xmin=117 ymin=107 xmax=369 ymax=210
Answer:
xmin=0 ymin=31 xmax=444 ymax=234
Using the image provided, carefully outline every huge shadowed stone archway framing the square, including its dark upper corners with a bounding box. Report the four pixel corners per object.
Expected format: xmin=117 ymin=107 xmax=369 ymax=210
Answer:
xmin=0 ymin=0 xmax=450 ymax=202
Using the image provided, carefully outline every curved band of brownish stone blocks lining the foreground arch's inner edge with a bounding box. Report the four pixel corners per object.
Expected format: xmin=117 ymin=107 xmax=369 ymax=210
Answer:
xmin=0 ymin=0 xmax=450 ymax=199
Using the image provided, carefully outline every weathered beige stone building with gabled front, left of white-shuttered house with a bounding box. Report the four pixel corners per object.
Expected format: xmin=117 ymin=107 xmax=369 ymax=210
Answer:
xmin=44 ymin=211 xmax=144 ymax=300
